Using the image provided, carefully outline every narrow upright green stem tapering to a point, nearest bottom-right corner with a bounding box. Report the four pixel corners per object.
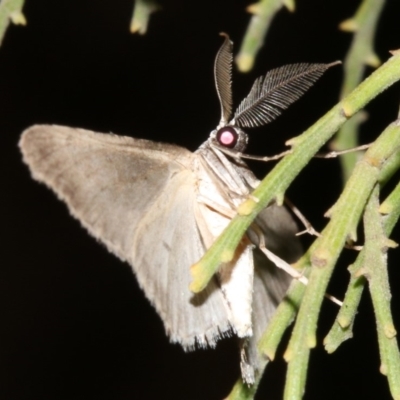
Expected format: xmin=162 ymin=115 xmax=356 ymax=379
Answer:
xmin=359 ymin=185 xmax=400 ymax=399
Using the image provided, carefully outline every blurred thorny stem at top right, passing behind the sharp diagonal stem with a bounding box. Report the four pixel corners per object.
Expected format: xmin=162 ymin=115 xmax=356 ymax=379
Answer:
xmin=331 ymin=0 xmax=385 ymax=182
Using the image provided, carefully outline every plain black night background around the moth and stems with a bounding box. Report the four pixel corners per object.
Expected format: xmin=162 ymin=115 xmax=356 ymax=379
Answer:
xmin=0 ymin=0 xmax=400 ymax=400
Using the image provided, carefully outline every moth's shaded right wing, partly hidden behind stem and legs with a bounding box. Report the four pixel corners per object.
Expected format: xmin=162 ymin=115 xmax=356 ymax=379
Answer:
xmin=242 ymin=205 xmax=302 ymax=383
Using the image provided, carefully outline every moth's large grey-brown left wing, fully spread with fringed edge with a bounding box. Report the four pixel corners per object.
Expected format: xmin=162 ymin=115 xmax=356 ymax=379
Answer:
xmin=20 ymin=125 xmax=230 ymax=349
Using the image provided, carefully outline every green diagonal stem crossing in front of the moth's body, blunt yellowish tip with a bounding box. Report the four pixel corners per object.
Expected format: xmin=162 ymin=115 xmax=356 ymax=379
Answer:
xmin=190 ymin=51 xmax=400 ymax=292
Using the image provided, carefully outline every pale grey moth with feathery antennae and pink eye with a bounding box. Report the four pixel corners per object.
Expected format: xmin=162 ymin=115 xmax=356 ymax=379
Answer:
xmin=19 ymin=35 xmax=331 ymax=384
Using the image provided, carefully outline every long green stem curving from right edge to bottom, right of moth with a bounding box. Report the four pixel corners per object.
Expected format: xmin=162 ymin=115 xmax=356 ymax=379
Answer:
xmin=284 ymin=122 xmax=400 ymax=400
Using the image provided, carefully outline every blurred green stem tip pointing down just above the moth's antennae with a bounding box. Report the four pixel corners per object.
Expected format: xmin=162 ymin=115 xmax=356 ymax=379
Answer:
xmin=235 ymin=0 xmax=294 ymax=72
